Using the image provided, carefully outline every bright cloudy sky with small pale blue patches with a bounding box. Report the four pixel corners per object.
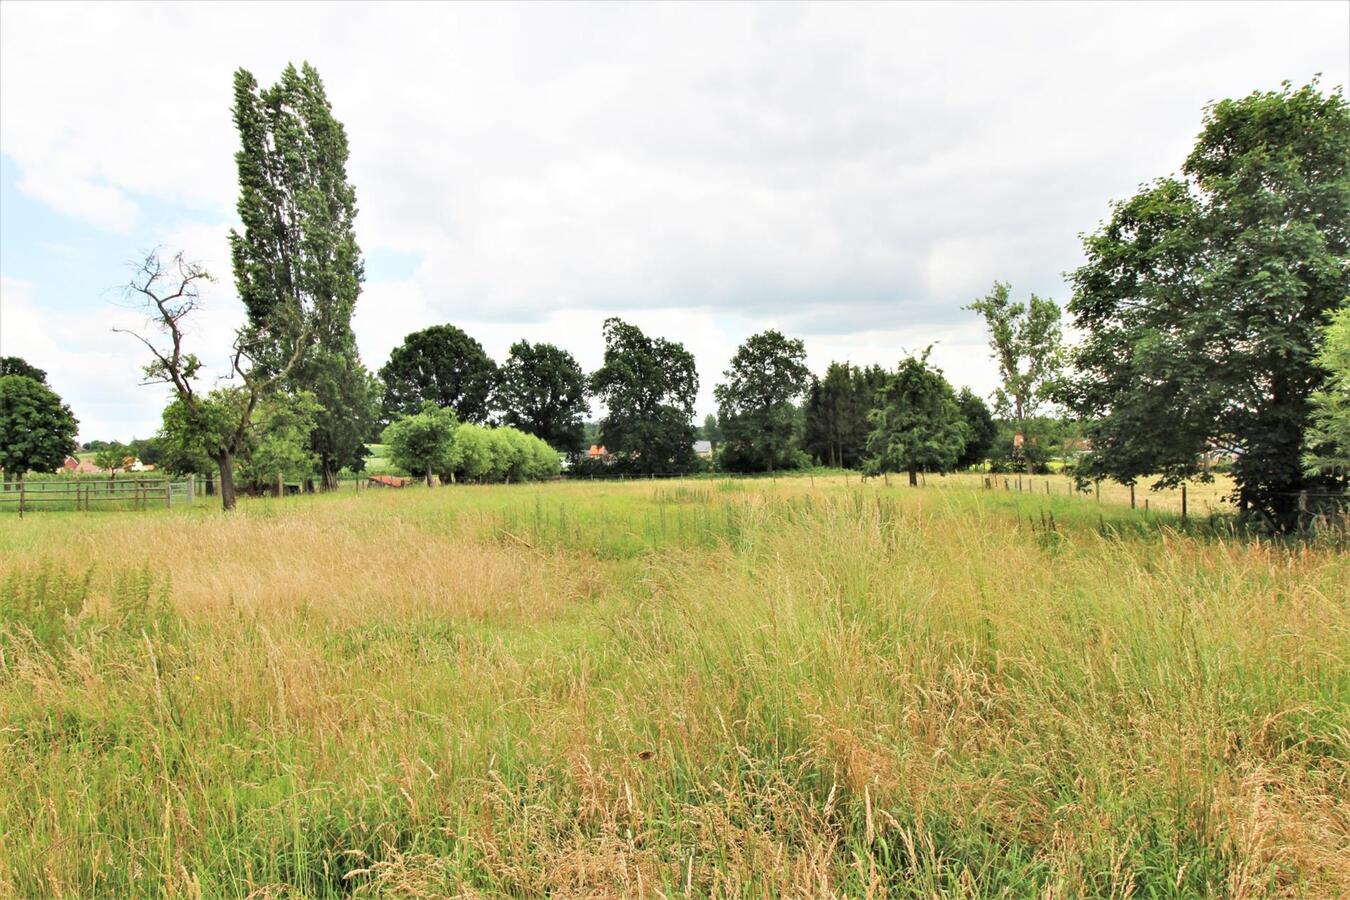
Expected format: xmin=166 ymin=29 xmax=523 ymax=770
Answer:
xmin=0 ymin=0 xmax=1350 ymax=440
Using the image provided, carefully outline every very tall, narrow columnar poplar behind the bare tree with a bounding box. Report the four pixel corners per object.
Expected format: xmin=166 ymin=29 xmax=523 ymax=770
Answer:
xmin=230 ymin=63 xmax=375 ymax=487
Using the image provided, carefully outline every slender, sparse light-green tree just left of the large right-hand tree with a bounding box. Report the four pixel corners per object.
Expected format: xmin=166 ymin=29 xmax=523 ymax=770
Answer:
xmin=967 ymin=281 xmax=1064 ymax=422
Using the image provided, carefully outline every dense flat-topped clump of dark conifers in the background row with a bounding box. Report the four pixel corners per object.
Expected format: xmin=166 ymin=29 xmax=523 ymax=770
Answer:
xmin=802 ymin=363 xmax=887 ymax=468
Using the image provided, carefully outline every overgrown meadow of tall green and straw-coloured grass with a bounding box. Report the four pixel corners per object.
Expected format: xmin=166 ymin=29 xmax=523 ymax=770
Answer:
xmin=0 ymin=478 xmax=1350 ymax=897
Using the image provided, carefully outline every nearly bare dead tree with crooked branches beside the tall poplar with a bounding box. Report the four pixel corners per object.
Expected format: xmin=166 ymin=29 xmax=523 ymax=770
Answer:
xmin=113 ymin=250 xmax=309 ymax=510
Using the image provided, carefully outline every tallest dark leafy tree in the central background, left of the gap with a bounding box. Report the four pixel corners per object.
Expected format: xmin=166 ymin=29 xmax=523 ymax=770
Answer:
xmin=591 ymin=318 xmax=698 ymax=474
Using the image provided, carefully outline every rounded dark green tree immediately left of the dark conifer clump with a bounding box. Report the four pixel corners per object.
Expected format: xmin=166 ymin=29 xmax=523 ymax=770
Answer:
xmin=713 ymin=329 xmax=811 ymax=472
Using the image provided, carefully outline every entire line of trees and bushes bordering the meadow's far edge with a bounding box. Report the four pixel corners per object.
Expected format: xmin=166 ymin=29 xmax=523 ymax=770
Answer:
xmin=0 ymin=72 xmax=1350 ymax=530
